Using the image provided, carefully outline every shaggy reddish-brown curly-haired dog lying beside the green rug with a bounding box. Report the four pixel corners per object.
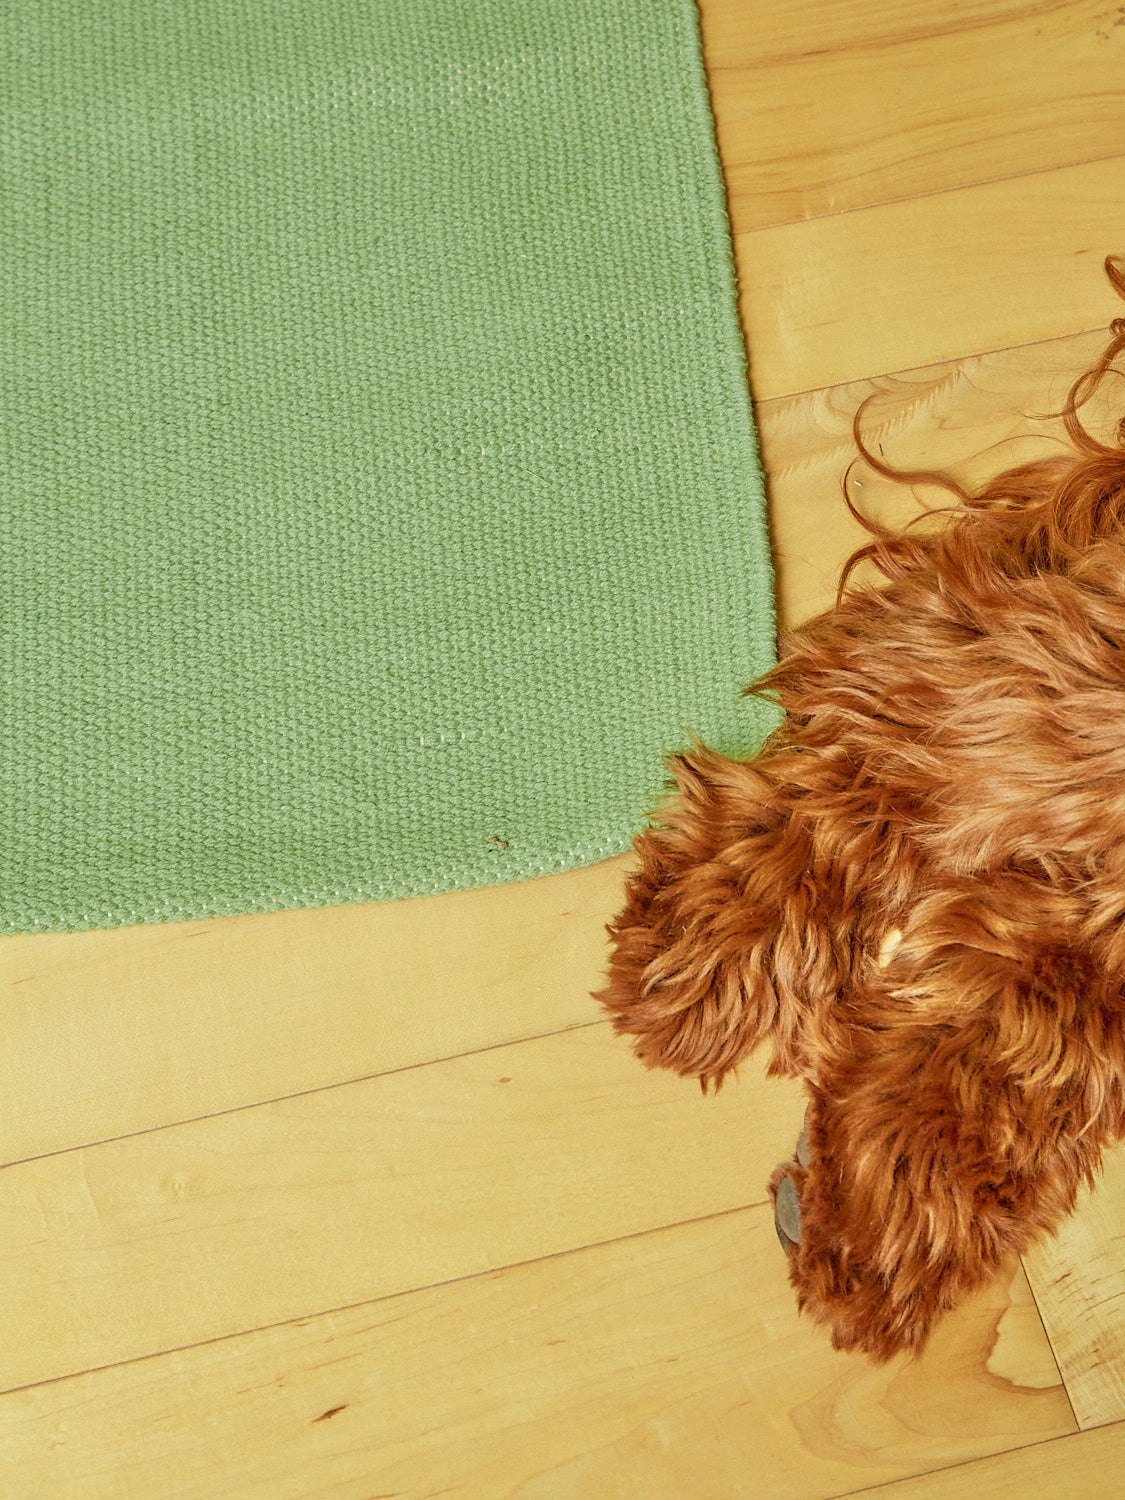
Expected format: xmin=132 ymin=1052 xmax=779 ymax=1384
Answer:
xmin=600 ymin=261 xmax=1125 ymax=1359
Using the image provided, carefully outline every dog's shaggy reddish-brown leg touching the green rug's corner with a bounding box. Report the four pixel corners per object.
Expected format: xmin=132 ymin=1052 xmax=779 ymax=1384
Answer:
xmin=597 ymin=749 xmax=851 ymax=1088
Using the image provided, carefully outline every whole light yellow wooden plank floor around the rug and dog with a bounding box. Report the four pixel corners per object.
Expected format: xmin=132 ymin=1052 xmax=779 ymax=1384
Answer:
xmin=0 ymin=0 xmax=1125 ymax=1500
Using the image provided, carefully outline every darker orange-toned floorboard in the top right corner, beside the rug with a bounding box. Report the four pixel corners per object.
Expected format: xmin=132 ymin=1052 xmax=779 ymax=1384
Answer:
xmin=704 ymin=0 xmax=1125 ymax=233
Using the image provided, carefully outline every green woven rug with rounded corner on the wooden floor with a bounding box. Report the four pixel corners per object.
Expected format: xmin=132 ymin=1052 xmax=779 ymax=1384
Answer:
xmin=0 ymin=0 xmax=774 ymax=932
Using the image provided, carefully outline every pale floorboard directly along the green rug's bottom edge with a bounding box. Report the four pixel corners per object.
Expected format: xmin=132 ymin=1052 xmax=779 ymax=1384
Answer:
xmin=0 ymin=858 xmax=629 ymax=1161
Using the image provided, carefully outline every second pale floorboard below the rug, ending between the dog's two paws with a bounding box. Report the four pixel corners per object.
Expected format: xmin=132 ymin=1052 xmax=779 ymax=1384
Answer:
xmin=0 ymin=1023 xmax=804 ymax=1389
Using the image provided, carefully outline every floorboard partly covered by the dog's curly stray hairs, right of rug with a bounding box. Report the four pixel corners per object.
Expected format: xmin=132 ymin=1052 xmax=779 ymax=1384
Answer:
xmin=758 ymin=332 xmax=1116 ymax=627
